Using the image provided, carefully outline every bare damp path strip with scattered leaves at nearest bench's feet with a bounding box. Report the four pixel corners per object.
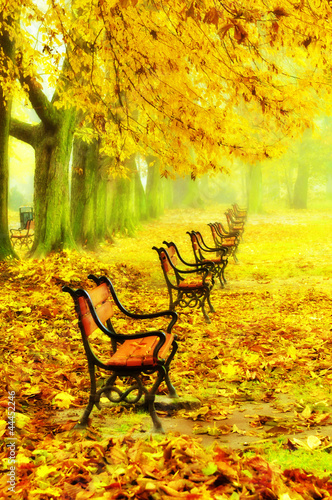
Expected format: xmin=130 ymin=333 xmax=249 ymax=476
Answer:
xmin=56 ymin=395 xmax=332 ymax=449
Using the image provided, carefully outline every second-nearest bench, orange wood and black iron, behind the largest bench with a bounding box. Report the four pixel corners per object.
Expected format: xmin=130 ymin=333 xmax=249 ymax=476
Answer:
xmin=153 ymin=243 xmax=215 ymax=323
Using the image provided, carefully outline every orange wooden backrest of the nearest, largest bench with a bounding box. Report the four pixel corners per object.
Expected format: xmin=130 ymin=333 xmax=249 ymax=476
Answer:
xmin=78 ymin=283 xmax=113 ymax=337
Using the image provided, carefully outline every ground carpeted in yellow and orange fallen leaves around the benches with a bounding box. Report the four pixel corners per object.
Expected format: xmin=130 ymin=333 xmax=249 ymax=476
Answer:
xmin=0 ymin=206 xmax=332 ymax=500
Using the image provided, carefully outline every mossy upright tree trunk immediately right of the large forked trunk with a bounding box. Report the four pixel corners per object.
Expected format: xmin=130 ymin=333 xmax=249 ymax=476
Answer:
xmin=71 ymin=138 xmax=100 ymax=249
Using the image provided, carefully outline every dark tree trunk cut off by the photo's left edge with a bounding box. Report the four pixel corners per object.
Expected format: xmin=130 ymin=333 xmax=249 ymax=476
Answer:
xmin=0 ymin=12 xmax=15 ymax=260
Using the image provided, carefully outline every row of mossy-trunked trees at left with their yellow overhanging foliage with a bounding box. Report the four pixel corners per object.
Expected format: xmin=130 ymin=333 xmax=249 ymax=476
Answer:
xmin=0 ymin=0 xmax=332 ymax=259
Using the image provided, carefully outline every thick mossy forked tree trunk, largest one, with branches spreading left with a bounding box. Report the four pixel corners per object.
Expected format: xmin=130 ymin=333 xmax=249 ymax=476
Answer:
xmin=10 ymin=58 xmax=76 ymax=257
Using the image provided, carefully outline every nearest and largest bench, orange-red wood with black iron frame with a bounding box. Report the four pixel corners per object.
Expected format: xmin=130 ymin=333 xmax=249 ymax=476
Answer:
xmin=62 ymin=275 xmax=178 ymax=432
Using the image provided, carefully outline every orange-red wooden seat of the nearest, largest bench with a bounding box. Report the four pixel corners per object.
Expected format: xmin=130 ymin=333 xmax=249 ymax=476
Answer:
xmin=106 ymin=333 xmax=174 ymax=367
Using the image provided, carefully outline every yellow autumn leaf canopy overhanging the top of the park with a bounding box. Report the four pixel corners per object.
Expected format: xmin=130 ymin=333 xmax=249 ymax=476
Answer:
xmin=2 ymin=0 xmax=332 ymax=175
